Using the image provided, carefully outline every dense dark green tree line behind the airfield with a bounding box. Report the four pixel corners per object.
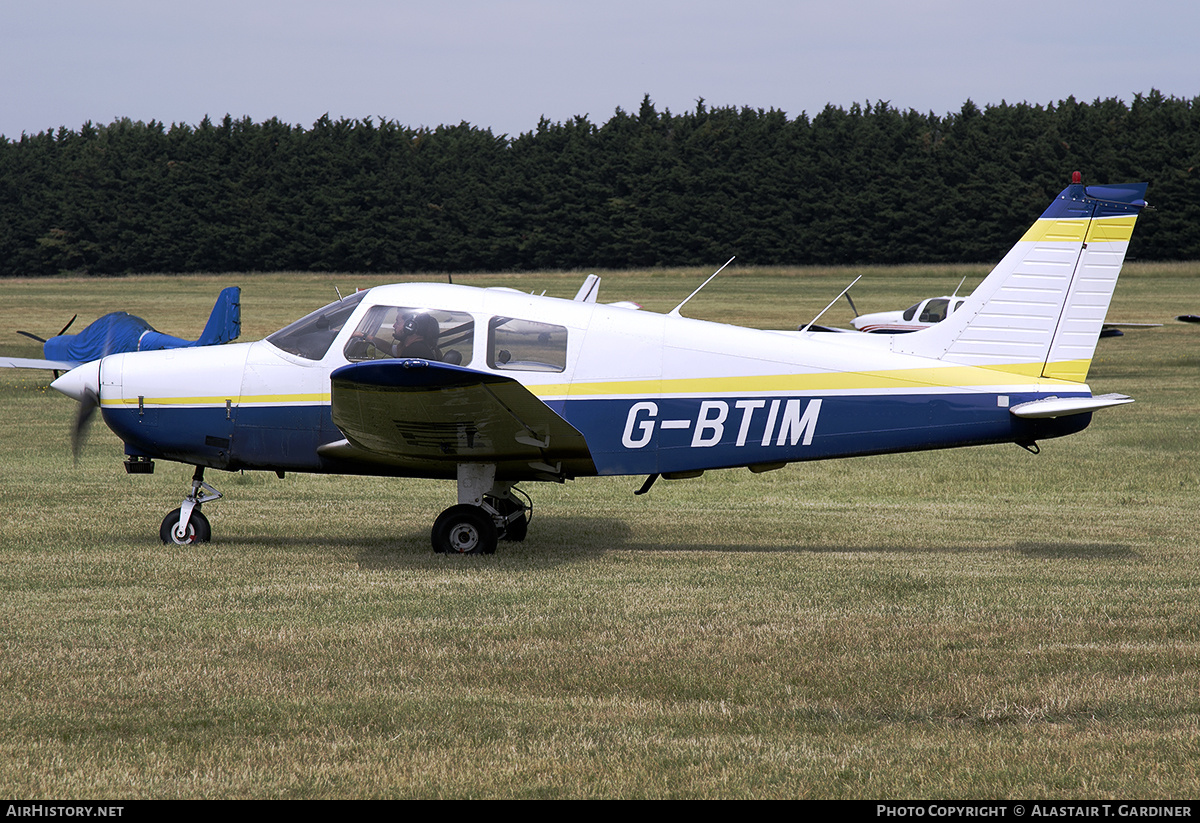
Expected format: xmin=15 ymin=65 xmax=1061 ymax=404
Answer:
xmin=0 ymin=91 xmax=1200 ymax=276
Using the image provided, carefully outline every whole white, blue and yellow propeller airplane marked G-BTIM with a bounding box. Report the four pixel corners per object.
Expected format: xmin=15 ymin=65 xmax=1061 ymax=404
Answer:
xmin=46 ymin=173 xmax=1146 ymax=553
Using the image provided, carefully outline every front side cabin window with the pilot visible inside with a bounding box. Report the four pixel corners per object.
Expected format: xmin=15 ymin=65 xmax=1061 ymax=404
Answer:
xmin=342 ymin=306 xmax=475 ymax=366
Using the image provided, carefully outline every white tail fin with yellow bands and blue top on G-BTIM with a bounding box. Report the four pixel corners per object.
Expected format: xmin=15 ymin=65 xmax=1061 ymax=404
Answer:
xmin=893 ymin=172 xmax=1146 ymax=383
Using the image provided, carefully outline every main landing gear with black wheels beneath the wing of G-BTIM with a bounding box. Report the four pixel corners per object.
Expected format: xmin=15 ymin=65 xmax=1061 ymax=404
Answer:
xmin=430 ymin=463 xmax=533 ymax=554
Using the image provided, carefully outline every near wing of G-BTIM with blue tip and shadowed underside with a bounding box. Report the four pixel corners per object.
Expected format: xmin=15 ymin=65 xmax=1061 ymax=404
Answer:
xmin=319 ymin=359 xmax=592 ymax=476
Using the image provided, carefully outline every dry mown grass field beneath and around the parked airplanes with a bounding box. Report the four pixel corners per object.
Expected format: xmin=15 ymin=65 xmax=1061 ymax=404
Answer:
xmin=0 ymin=264 xmax=1200 ymax=799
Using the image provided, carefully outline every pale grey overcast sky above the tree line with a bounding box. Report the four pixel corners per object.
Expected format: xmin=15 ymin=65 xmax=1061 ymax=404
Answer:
xmin=0 ymin=0 xmax=1200 ymax=138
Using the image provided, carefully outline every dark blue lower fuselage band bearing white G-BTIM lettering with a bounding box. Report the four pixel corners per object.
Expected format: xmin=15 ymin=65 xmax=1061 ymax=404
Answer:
xmin=103 ymin=392 xmax=1091 ymax=475
